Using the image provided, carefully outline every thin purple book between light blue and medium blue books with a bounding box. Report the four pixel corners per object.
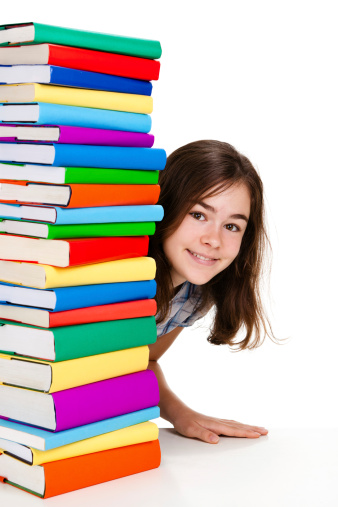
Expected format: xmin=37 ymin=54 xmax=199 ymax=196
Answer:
xmin=0 ymin=124 xmax=154 ymax=148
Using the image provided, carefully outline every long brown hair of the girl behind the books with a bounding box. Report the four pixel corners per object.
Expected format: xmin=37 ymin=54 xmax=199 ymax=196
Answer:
xmin=149 ymin=140 xmax=273 ymax=350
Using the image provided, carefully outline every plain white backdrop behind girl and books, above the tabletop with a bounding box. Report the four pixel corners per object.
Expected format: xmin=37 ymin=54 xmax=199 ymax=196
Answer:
xmin=1 ymin=0 xmax=338 ymax=428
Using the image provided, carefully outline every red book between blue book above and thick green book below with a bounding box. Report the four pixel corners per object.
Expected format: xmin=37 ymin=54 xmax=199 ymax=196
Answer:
xmin=0 ymin=299 xmax=157 ymax=328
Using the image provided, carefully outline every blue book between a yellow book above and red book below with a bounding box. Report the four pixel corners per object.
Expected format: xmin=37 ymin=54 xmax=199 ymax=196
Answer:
xmin=0 ymin=280 xmax=156 ymax=312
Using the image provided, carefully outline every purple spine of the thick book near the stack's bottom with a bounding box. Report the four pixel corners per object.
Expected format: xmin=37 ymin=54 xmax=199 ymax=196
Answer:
xmin=50 ymin=370 xmax=159 ymax=431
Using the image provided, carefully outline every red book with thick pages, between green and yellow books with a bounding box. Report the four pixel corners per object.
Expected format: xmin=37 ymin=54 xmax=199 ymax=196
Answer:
xmin=0 ymin=234 xmax=149 ymax=268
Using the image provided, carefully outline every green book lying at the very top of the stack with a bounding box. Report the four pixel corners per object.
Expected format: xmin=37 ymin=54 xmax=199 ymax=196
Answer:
xmin=0 ymin=22 xmax=162 ymax=60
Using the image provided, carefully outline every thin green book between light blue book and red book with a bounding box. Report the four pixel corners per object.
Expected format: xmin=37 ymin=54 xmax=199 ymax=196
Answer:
xmin=0 ymin=218 xmax=155 ymax=239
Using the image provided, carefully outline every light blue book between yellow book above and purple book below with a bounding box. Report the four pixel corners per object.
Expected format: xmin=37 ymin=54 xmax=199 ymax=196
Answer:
xmin=0 ymin=102 xmax=151 ymax=134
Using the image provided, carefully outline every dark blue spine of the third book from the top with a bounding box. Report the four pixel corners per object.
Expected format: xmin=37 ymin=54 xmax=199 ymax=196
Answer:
xmin=50 ymin=65 xmax=152 ymax=96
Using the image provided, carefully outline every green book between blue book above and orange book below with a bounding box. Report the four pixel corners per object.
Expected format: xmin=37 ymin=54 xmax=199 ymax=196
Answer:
xmin=0 ymin=163 xmax=159 ymax=185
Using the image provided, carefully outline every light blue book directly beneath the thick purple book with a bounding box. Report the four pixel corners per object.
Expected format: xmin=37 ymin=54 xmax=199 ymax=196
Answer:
xmin=0 ymin=407 xmax=160 ymax=451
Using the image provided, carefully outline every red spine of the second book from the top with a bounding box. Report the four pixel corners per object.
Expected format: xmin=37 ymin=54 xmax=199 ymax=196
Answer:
xmin=48 ymin=44 xmax=160 ymax=81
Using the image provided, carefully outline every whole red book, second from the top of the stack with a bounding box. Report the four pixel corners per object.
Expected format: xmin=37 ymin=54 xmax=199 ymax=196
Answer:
xmin=0 ymin=44 xmax=160 ymax=81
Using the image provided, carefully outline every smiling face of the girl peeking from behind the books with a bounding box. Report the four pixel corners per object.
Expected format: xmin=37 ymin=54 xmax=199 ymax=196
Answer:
xmin=163 ymin=183 xmax=250 ymax=287
